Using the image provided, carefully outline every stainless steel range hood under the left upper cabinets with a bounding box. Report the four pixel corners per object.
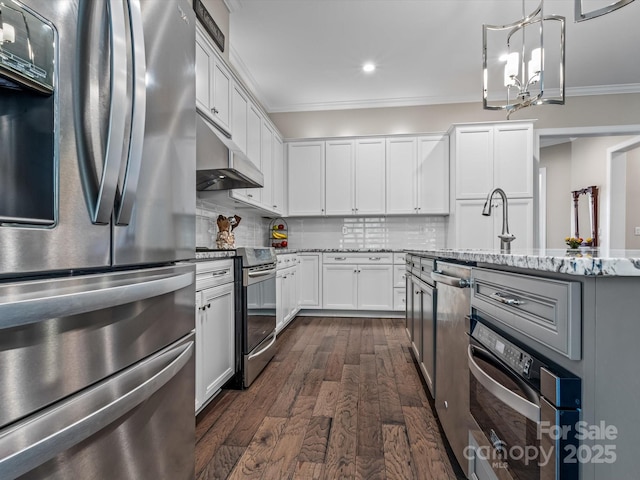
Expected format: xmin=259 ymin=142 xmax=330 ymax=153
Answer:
xmin=196 ymin=113 xmax=264 ymax=192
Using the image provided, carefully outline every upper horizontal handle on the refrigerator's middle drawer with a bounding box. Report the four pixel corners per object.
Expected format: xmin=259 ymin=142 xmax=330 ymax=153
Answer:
xmin=0 ymin=272 xmax=195 ymax=330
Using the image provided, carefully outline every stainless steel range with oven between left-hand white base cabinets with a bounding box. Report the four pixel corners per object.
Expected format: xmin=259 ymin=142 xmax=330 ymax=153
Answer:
xmin=235 ymin=248 xmax=276 ymax=388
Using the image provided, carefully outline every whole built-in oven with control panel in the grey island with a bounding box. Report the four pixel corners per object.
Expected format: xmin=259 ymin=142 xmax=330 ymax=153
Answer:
xmin=467 ymin=316 xmax=581 ymax=480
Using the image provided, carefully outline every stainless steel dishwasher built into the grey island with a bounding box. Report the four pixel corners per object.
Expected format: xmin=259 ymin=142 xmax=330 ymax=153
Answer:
xmin=431 ymin=261 xmax=472 ymax=475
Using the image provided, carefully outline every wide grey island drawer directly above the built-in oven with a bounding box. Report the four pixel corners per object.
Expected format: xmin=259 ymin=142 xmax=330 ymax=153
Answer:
xmin=471 ymin=268 xmax=582 ymax=360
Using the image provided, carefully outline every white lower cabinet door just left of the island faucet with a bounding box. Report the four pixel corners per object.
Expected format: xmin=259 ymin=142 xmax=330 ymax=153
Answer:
xmin=454 ymin=200 xmax=496 ymax=249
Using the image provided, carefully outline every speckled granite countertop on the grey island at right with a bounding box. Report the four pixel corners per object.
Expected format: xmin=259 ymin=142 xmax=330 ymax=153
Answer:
xmin=405 ymin=248 xmax=640 ymax=277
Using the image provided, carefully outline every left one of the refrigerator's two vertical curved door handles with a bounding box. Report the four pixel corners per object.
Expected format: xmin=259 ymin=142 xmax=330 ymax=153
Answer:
xmin=91 ymin=0 xmax=127 ymax=224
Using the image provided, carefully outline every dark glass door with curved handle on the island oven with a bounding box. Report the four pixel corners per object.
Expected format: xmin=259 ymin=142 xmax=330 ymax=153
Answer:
xmin=468 ymin=339 xmax=546 ymax=480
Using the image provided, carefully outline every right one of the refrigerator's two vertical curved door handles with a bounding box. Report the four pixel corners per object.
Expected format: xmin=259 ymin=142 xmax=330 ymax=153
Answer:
xmin=116 ymin=0 xmax=147 ymax=225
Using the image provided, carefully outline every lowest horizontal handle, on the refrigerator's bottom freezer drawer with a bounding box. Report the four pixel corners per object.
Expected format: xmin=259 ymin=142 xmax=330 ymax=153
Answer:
xmin=0 ymin=341 xmax=194 ymax=479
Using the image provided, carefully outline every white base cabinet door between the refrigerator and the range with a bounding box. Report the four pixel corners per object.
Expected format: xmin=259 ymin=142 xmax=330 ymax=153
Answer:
xmin=196 ymin=283 xmax=235 ymax=402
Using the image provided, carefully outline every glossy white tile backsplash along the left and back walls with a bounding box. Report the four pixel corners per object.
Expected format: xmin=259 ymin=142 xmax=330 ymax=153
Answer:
xmin=196 ymin=199 xmax=446 ymax=249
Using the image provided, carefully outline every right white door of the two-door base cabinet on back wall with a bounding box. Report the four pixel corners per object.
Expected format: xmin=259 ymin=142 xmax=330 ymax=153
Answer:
xmin=357 ymin=265 xmax=393 ymax=310
